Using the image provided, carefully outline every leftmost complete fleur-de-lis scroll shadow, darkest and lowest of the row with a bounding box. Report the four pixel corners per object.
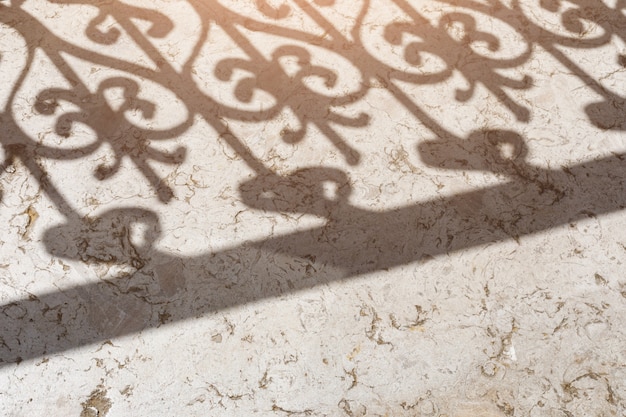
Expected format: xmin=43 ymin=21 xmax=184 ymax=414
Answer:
xmin=35 ymin=77 xmax=190 ymax=202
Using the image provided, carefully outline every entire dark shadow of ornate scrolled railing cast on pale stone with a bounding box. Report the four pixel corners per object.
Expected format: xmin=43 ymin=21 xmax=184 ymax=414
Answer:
xmin=0 ymin=0 xmax=626 ymax=364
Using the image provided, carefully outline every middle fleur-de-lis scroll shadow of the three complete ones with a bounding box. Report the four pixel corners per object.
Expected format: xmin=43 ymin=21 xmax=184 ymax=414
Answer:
xmin=215 ymin=45 xmax=369 ymax=165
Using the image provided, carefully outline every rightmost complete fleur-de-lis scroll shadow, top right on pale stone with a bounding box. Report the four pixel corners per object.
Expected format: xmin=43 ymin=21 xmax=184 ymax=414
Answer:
xmin=384 ymin=12 xmax=531 ymax=122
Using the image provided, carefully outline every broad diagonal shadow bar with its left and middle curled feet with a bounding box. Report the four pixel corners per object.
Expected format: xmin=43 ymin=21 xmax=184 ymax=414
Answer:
xmin=0 ymin=148 xmax=626 ymax=366
